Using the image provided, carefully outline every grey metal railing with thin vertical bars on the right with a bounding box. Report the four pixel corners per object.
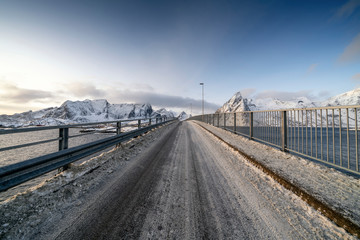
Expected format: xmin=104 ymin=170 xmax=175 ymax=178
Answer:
xmin=190 ymin=106 xmax=360 ymax=175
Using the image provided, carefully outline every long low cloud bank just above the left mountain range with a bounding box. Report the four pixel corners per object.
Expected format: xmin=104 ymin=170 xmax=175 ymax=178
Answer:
xmin=0 ymin=79 xmax=220 ymax=114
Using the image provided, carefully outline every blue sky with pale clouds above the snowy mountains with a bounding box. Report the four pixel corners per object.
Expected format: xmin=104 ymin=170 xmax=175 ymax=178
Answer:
xmin=0 ymin=0 xmax=360 ymax=114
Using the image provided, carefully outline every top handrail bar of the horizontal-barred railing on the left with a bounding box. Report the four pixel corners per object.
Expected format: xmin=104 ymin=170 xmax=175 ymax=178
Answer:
xmin=0 ymin=117 xmax=169 ymax=135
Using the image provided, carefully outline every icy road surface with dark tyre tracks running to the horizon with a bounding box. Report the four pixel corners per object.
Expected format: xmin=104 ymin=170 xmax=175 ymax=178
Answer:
xmin=0 ymin=122 xmax=356 ymax=239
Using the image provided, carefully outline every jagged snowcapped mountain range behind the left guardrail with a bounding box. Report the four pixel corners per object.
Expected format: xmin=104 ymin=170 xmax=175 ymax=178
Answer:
xmin=0 ymin=99 xmax=175 ymax=127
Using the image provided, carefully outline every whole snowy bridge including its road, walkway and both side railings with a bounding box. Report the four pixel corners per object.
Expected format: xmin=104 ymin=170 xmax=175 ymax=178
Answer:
xmin=0 ymin=106 xmax=360 ymax=239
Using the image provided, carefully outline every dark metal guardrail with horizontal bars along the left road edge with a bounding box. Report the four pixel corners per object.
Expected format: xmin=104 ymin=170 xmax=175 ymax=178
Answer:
xmin=0 ymin=118 xmax=176 ymax=192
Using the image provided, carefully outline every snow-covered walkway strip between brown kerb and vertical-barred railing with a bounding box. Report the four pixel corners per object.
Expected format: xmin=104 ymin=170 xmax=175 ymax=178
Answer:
xmin=197 ymin=122 xmax=360 ymax=228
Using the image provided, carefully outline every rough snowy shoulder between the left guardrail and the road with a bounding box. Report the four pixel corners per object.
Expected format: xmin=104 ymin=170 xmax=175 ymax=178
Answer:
xmin=0 ymin=125 xmax=177 ymax=239
